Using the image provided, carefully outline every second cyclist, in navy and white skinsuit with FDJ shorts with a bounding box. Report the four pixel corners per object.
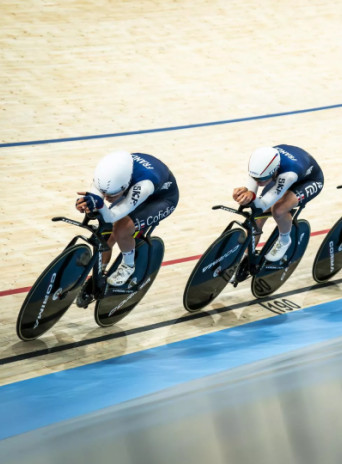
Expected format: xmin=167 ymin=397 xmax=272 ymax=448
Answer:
xmin=233 ymin=145 xmax=324 ymax=261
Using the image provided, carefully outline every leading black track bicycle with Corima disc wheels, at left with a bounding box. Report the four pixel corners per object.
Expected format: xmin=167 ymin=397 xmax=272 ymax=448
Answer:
xmin=16 ymin=213 xmax=164 ymax=341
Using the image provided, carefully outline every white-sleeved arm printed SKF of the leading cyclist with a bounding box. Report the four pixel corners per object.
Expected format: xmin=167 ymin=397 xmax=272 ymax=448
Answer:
xmin=99 ymin=180 xmax=154 ymax=223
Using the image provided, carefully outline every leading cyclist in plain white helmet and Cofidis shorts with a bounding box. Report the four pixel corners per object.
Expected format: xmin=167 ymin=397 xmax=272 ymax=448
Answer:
xmin=76 ymin=151 xmax=179 ymax=286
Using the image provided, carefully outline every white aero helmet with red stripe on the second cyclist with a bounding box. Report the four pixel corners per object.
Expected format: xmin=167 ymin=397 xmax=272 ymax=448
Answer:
xmin=248 ymin=147 xmax=280 ymax=182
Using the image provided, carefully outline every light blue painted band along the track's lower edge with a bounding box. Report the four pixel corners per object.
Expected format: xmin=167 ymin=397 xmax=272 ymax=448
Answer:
xmin=0 ymin=300 xmax=342 ymax=439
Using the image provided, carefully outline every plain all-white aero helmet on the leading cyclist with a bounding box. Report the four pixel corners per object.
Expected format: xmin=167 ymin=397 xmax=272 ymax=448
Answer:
xmin=94 ymin=150 xmax=133 ymax=195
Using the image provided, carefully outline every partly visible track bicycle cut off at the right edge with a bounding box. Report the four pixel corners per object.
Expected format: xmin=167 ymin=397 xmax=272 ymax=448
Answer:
xmin=312 ymin=185 xmax=342 ymax=283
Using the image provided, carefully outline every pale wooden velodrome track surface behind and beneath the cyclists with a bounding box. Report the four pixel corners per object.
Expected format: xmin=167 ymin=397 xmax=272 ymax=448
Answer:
xmin=0 ymin=0 xmax=342 ymax=385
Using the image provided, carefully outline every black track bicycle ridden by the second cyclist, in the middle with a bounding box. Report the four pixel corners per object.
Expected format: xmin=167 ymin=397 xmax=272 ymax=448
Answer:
xmin=183 ymin=205 xmax=310 ymax=312
